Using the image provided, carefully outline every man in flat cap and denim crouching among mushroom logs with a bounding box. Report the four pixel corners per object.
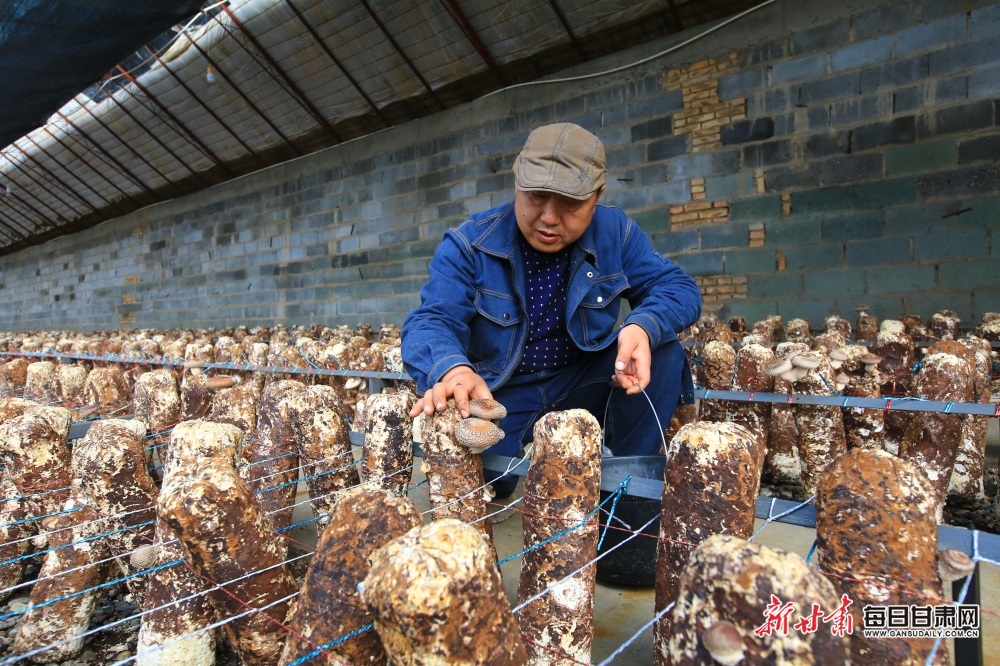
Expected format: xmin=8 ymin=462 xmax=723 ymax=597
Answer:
xmin=402 ymin=123 xmax=701 ymax=497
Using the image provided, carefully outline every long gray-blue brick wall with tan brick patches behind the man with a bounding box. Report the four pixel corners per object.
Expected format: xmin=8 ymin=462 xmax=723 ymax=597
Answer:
xmin=0 ymin=0 xmax=1000 ymax=330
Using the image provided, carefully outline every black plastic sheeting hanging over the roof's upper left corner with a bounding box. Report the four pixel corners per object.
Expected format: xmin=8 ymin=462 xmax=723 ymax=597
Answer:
xmin=0 ymin=0 xmax=205 ymax=146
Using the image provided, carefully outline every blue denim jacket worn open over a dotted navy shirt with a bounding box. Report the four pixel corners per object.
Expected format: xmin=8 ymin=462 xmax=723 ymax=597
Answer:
xmin=402 ymin=203 xmax=701 ymax=393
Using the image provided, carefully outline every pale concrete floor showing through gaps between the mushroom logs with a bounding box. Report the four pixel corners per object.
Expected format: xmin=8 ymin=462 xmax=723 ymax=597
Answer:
xmin=291 ymin=422 xmax=1000 ymax=666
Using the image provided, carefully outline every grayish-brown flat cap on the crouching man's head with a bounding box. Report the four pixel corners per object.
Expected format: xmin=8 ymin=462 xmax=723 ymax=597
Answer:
xmin=514 ymin=123 xmax=606 ymax=200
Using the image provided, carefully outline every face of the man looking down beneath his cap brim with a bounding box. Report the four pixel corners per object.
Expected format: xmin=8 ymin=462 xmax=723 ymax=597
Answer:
xmin=514 ymin=187 xmax=604 ymax=252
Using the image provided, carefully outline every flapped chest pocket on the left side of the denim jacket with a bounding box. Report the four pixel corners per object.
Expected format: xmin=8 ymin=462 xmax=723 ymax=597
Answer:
xmin=469 ymin=289 xmax=521 ymax=374
